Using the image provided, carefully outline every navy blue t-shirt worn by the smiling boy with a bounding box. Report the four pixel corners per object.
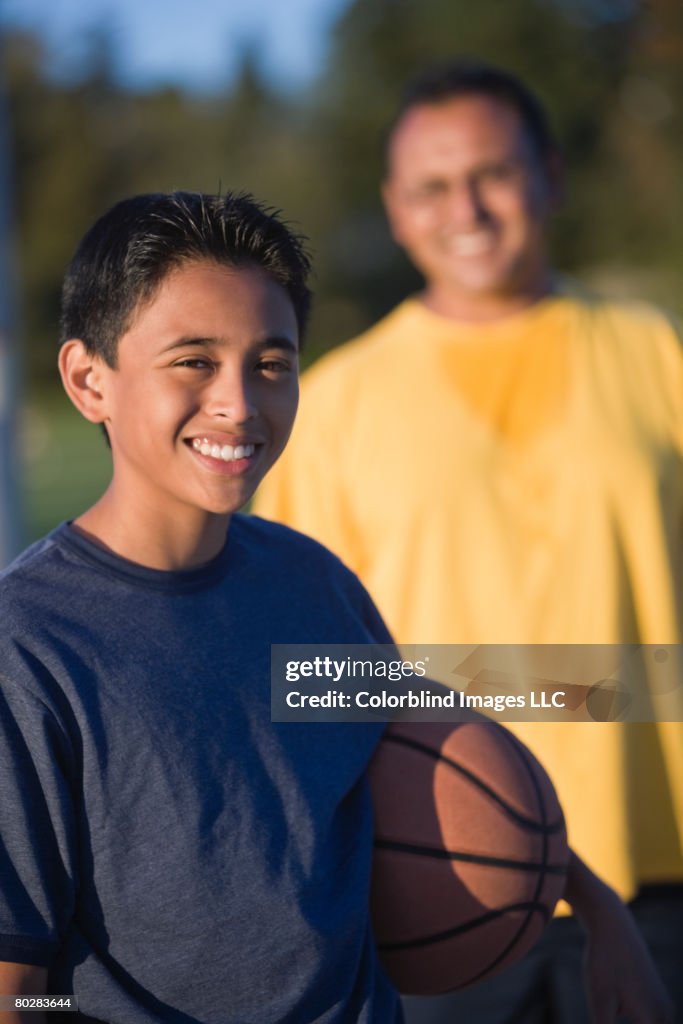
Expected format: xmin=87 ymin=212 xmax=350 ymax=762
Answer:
xmin=0 ymin=515 xmax=399 ymax=1024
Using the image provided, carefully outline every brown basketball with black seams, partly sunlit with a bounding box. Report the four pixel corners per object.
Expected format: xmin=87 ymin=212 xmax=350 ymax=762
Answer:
xmin=370 ymin=722 xmax=569 ymax=995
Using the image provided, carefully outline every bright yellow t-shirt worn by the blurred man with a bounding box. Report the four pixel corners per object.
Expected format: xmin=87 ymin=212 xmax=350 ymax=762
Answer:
xmin=255 ymin=295 xmax=683 ymax=897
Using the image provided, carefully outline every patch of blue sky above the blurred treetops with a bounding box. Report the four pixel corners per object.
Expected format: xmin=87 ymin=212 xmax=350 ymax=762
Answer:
xmin=0 ymin=0 xmax=349 ymax=92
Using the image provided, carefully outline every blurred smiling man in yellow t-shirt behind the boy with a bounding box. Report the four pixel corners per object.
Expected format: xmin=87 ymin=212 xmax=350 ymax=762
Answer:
xmin=256 ymin=63 xmax=683 ymax=1024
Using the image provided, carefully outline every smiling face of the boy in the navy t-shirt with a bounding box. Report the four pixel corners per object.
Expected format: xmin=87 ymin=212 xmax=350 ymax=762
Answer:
xmin=88 ymin=262 xmax=298 ymax=522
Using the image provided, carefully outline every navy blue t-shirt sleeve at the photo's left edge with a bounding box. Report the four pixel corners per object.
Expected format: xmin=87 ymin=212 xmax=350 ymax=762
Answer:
xmin=0 ymin=669 xmax=77 ymax=967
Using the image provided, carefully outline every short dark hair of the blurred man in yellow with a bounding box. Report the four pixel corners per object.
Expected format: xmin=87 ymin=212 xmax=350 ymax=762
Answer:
xmin=386 ymin=57 xmax=557 ymax=161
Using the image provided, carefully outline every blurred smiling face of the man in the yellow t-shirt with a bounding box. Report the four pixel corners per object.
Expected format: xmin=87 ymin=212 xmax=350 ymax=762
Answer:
xmin=384 ymin=95 xmax=556 ymax=310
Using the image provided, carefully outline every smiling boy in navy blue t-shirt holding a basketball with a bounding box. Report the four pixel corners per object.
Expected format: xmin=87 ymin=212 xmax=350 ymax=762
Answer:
xmin=0 ymin=193 xmax=669 ymax=1024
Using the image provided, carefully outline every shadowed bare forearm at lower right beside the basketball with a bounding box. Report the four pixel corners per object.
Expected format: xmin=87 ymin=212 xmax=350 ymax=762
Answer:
xmin=564 ymin=853 xmax=675 ymax=1024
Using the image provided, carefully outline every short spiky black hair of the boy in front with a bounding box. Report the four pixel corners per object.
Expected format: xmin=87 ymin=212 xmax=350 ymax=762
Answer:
xmin=59 ymin=191 xmax=310 ymax=368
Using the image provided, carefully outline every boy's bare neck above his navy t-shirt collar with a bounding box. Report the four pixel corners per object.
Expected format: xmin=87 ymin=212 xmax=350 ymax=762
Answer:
xmin=73 ymin=489 xmax=230 ymax=571
